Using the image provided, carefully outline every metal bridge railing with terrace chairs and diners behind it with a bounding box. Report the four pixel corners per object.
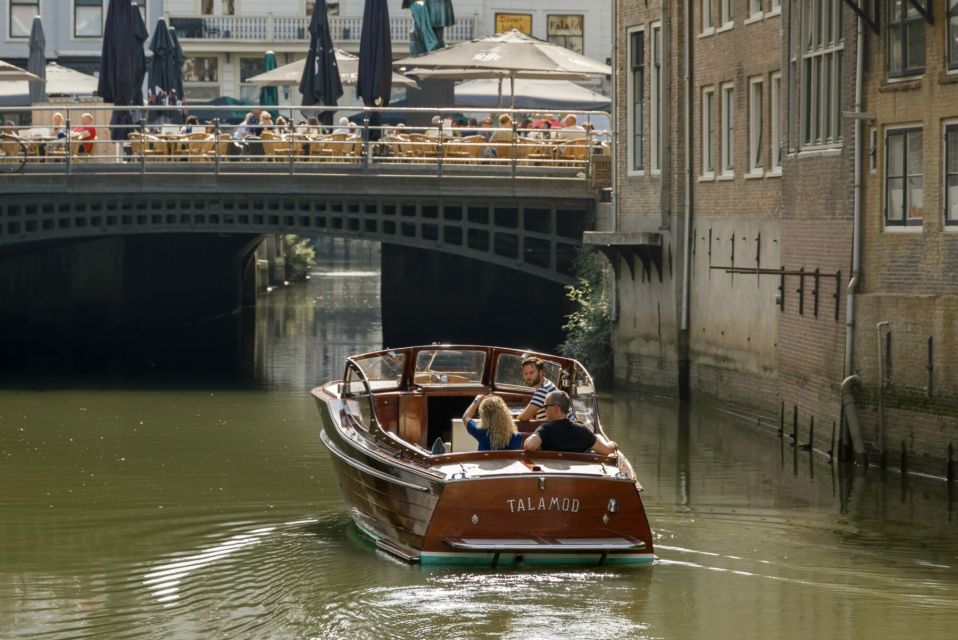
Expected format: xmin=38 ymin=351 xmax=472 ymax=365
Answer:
xmin=0 ymin=104 xmax=611 ymax=180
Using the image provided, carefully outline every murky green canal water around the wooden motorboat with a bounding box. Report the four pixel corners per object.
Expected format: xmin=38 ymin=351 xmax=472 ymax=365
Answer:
xmin=0 ymin=252 xmax=958 ymax=640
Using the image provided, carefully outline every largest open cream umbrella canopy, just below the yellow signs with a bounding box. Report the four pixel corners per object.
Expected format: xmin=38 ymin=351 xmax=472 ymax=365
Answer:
xmin=393 ymin=29 xmax=612 ymax=77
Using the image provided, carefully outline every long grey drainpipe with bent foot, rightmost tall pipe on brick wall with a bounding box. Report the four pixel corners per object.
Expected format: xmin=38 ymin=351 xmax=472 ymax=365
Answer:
xmin=841 ymin=17 xmax=868 ymax=466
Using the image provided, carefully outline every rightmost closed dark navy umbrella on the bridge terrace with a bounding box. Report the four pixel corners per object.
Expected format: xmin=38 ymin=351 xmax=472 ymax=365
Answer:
xmin=356 ymin=0 xmax=393 ymax=140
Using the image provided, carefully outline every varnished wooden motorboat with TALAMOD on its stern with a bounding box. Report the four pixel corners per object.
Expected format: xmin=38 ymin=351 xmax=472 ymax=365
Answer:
xmin=312 ymin=345 xmax=654 ymax=565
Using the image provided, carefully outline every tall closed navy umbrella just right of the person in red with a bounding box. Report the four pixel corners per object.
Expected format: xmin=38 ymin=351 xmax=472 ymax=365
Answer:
xmin=97 ymin=0 xmax=143 ymax=140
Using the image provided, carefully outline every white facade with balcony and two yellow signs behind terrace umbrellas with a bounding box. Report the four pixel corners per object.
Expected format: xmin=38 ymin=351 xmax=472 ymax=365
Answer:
xmin=163 ymin=0 xmax=612 ymax=103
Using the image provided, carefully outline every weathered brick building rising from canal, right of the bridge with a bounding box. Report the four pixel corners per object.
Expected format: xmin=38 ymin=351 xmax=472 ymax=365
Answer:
xmin=608 ymin=0 xmax=958 ymax=475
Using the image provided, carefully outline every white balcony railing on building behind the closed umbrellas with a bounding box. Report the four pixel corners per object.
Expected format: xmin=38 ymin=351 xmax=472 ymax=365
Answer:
xmin=169 ymin=15 xmax=476 ymax=44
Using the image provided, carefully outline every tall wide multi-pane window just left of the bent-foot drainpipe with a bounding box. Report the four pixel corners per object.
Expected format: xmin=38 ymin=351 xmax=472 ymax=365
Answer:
xmin=800 ymin=0 xmax=844 ymax=146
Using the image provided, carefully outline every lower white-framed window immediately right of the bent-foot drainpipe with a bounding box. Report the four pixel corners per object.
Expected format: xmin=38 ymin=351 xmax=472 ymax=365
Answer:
xmin=885 ymin=129 xmax=924 ymax=226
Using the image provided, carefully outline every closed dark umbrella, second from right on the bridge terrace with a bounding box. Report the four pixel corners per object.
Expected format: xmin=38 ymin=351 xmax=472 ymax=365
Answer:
xmin=302 ymin=0 xmax=343 ymax=126
